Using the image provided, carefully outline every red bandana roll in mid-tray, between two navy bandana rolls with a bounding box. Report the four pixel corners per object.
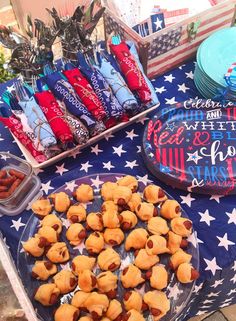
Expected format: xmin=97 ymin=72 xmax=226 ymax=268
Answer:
xmin=63 ymin=68 xmax=107 ymax=120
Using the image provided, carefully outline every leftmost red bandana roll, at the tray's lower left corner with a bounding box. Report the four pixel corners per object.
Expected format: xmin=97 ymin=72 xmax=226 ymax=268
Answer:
xmin=0 ymin=115 xmax=47 ymax=163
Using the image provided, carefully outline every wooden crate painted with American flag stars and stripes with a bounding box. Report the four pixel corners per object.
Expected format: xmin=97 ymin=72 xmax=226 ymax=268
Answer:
xmin=104 ymin=0 xmax=236 ymax=78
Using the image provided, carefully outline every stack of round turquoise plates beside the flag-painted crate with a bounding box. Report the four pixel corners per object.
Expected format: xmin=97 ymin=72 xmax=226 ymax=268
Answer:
xmin=194 ymin=27 xmax=236 ymax=100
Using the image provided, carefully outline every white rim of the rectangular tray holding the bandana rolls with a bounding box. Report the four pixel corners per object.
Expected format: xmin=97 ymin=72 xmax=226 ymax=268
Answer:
xmin=13 ymin=103 xmax=160 ymax=168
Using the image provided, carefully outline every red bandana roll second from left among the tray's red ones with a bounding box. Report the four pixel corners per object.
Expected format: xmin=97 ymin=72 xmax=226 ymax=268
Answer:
xmin=35 ymin=91 xmax=73 ymax=144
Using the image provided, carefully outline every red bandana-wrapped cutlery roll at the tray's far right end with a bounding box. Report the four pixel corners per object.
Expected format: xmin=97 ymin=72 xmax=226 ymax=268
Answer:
xmin=110 ymin=41 xmax=151 ymax=103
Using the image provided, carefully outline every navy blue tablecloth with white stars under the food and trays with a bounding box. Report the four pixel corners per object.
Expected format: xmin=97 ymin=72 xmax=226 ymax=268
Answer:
xmin=0 ymin=61 xmax=236 ymax=321
